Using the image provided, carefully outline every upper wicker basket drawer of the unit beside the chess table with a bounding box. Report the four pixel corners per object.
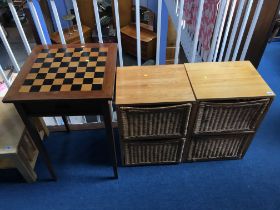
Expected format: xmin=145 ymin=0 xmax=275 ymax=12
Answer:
xmin=118 ymin=104 xmax=192 ymax=140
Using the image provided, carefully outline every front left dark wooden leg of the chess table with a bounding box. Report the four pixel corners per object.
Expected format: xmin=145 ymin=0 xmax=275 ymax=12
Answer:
xmin=15 ymin=104 xmax=57 ymax=180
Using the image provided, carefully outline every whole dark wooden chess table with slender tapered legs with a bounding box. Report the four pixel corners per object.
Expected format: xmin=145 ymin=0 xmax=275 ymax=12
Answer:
xmin=3 ymin=44 xmax=117 ymax=178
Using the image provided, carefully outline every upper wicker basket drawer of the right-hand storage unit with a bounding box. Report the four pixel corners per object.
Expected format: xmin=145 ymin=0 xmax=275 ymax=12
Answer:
xmin=194 ymin=99 xmax=270 ymax=133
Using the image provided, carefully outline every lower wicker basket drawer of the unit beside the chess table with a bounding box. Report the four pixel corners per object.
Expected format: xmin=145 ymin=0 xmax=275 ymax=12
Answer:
xmin=122 ymin=139 xmax=185 ymax=166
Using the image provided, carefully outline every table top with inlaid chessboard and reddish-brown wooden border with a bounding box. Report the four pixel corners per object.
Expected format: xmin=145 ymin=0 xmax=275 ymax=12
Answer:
xmin=3 ymin=43 xmax=117 ymax=102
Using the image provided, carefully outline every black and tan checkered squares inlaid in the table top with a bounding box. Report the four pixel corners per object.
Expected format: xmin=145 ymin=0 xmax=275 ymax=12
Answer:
xmin=19 ymin=47 xmax=108 ymax=93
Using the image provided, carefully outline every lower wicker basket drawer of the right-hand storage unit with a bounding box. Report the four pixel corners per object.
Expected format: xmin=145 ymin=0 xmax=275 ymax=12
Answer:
xmin=186 ymin=134 xmax=252 ymax=161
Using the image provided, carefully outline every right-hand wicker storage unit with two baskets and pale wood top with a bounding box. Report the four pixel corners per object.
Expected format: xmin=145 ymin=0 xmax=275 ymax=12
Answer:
xmin=183 ymin=61 xmax=274 ymax=161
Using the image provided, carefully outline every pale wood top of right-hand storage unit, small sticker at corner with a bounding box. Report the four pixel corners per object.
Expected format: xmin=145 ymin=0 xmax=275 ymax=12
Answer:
xmin=185 ymin=61 xmax=274 ymax=100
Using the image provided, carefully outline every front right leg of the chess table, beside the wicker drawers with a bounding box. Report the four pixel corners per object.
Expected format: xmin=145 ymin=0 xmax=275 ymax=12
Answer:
xmin=103 ymin=102 xmax=118 ymax=179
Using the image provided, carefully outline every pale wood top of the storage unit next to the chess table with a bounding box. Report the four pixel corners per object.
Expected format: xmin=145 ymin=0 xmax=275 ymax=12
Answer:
xmin=116 ymin=65 xmax=195 ymax=105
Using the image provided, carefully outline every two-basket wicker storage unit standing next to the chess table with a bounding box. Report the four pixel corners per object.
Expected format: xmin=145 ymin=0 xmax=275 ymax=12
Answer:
xmin=116 ymin=65 xmax=195 ymax=166
